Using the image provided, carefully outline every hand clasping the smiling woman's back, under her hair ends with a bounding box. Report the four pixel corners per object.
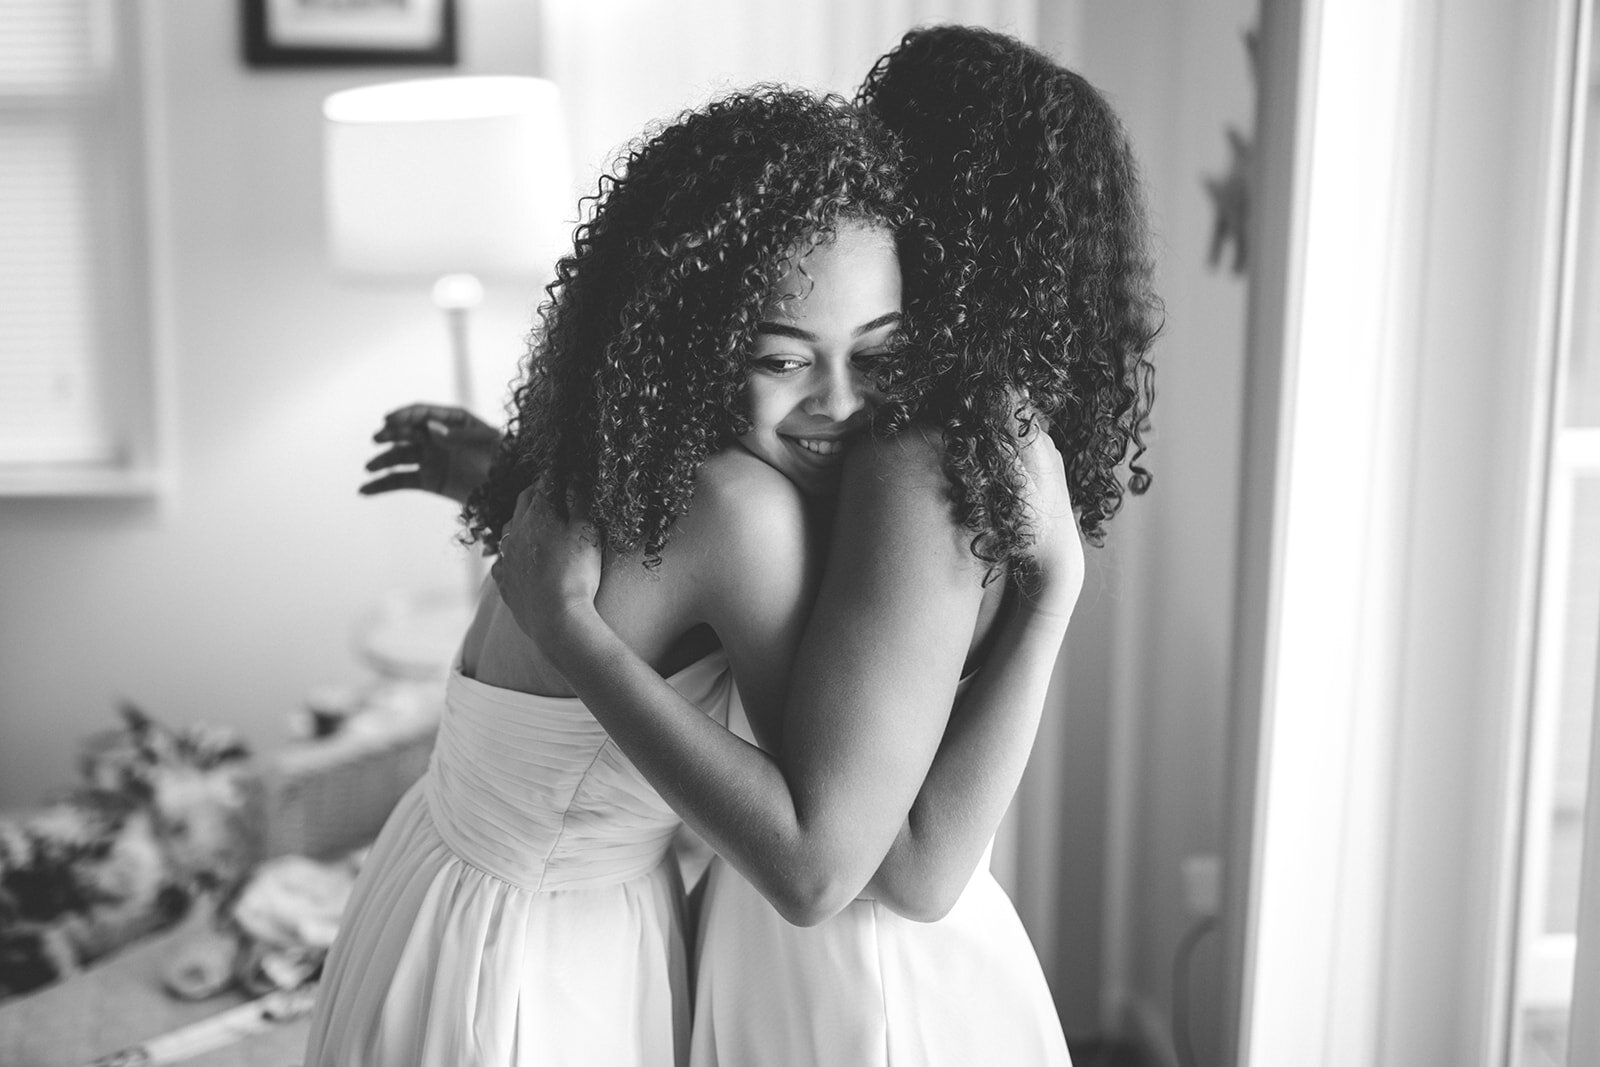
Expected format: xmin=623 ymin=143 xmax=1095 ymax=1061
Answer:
xmin=490 ymin=486 xmax=602 ymax=653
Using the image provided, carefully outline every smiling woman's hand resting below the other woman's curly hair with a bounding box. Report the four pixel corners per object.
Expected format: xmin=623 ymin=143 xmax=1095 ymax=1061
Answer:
xmin=1018 ymin=418 xmax=1083 ymax=621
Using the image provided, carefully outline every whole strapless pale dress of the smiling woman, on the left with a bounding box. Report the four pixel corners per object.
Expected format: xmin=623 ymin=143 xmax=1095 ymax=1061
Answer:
xmin=306 ymin=651 xmax=733 ymax=1067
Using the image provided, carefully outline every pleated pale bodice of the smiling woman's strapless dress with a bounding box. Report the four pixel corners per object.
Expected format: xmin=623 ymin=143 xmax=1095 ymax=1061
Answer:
xmin=424 ymin=651 xmax=733 ymax=893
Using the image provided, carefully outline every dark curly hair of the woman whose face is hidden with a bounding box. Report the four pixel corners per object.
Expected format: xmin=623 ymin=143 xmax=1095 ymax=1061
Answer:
xmin=858 ymin=26 xmax=1160 ymax=565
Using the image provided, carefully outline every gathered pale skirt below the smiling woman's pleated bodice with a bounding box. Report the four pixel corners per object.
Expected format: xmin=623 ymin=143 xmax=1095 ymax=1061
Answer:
xmin=306 ymin=787 xmax=690 ymax=1067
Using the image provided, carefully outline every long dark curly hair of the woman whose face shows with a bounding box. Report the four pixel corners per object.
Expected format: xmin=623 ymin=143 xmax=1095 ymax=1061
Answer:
xmin=464 ymin=86 xmax=914 ymax=565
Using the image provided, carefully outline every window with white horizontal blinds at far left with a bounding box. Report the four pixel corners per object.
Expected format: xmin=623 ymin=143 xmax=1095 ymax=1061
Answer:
xmin=0 ymin=0 xmax=155 ymax=494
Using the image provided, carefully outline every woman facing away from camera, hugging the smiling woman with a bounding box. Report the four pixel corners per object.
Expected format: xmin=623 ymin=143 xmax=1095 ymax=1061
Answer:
xmin=494 ymin=18 xmax=1157 ymax=1065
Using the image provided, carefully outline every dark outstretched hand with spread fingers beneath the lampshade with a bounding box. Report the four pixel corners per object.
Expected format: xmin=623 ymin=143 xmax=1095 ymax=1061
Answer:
xmin=362 ymin=403 xmax=501 ymax=504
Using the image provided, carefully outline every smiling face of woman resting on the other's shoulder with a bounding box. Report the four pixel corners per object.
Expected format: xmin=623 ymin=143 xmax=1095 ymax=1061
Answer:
xmin=739 ymin=222 xmax=901 ymax=494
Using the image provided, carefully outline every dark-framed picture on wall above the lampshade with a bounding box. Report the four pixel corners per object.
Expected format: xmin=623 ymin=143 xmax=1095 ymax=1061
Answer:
xmin=240 ymin=0 xmax=456 ymax=67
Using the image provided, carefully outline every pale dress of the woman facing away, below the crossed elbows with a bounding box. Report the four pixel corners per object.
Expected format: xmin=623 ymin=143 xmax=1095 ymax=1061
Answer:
xmin=690 ymin=687 xmax=1072 ymax=1067
